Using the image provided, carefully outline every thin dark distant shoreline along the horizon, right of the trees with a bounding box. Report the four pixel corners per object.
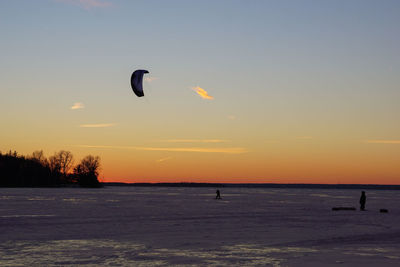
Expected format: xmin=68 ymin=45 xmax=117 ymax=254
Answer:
xmin=101 ymin=182 xmax=400 ymax=190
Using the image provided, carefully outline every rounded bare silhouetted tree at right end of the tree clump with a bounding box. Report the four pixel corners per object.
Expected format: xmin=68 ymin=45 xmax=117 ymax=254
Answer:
xmin=74 ymin=155 xmax=100 ymax=187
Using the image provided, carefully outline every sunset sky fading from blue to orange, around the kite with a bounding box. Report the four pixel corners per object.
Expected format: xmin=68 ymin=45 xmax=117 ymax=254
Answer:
xmin=0 ymin=0 xmax=400 ymax=184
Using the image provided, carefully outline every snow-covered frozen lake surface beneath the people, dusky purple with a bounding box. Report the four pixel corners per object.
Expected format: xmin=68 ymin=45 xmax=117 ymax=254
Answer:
xmin=0 ymin=186 xmax=400 ymax=266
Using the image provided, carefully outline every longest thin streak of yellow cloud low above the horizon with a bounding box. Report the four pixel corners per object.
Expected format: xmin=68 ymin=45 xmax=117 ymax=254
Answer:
xmin=77 ymin=145 xmax=248 ymax=154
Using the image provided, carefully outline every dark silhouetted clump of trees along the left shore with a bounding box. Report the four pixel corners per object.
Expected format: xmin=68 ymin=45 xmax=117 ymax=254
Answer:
xmin=0 ymin=150 xmax=101 ymax=187
